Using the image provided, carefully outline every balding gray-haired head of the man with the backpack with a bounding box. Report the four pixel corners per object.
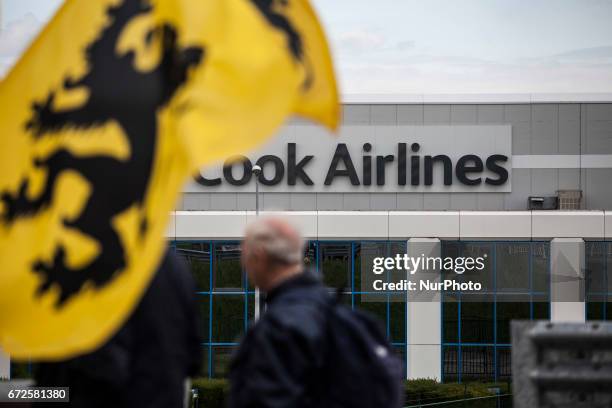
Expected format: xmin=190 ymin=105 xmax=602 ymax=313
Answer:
xmin=242 ymin=218 xmax=304 ymax=291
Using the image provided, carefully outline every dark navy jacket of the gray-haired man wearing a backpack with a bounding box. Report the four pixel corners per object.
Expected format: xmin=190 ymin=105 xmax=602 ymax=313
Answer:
xmin=230 ymin=272 xmax=330 ymax=408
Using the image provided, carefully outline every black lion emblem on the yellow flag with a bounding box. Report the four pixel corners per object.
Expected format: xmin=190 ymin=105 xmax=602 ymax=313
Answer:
xmin=0 ymin=0 xmax=303 ymax=308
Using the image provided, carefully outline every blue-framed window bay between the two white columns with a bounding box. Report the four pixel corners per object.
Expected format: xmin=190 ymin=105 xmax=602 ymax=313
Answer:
xmin=441 ymin=241 xmax=550 ymax=382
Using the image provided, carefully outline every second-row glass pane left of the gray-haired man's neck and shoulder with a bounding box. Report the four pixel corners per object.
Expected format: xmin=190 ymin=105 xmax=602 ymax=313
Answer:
xmin=212 ymin=295 xmax=245 ymax=343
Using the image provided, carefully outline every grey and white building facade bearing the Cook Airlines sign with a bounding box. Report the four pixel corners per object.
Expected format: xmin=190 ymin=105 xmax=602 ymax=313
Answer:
xmin=168 ymin=95 xmax=612 ymax=381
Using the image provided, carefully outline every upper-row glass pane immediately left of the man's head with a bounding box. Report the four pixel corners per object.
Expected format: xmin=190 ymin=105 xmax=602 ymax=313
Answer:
xmin=213 ymin=242 xmax=244 ymax=291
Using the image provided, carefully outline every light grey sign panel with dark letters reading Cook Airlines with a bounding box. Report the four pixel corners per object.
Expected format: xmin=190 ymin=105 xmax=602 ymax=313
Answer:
xmin=186 ymin=125 xmax=512 ymax=193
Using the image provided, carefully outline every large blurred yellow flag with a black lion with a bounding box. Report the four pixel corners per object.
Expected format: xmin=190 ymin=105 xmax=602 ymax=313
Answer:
xmin=0 ymin=0 xmax=338 ymax=360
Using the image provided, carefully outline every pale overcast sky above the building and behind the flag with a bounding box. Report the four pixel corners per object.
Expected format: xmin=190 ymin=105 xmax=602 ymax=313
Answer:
xmin=0 ymin=0 xmax=612 ymax=94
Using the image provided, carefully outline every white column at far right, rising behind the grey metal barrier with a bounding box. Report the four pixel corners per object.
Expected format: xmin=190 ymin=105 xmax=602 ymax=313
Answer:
xmin=550 ymin=238 xmax=586 ymax=322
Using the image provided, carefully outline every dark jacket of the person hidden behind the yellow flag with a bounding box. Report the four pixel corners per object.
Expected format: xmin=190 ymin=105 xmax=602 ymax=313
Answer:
xmin=35 ymin=251 xmax=202 ymax=408
